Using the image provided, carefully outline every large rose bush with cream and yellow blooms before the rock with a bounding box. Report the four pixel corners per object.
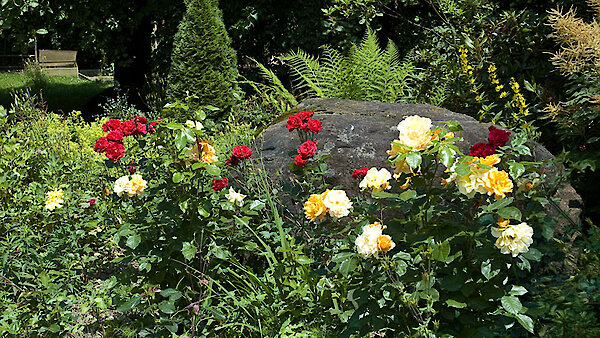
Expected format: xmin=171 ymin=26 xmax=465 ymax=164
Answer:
xmin=318 ymin=116 xmax=564 ymax=336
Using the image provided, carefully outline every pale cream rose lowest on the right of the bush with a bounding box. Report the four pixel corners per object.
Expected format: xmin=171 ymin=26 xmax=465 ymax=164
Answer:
xmin=492 ymin=222 xmax=533 ymax=257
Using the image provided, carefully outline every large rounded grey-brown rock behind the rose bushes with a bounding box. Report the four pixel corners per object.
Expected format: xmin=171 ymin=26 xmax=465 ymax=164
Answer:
xmin=257 ymin=99 xmax=581 ymax=221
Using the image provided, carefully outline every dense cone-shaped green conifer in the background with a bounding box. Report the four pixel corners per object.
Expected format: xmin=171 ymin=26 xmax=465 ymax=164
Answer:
xmin=168 ymin=0 xmax=239 ymax=115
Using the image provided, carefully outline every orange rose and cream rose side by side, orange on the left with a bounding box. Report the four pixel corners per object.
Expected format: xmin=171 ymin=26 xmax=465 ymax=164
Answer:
xmin=304 ymin=190 xmax=352 ymax=221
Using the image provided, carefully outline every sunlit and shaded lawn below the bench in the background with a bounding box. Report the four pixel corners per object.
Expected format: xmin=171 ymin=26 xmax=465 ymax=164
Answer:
xmin=0 ymin=73 xmax=112 ymax=112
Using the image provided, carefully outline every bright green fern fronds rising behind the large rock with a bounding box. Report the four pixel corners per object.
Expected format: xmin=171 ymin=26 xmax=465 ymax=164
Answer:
xmin=280 ymin=29 xmax=415 ymax=102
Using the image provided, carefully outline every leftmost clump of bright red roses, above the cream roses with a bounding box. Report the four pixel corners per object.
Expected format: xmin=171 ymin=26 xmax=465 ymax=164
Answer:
xmin=94 ymin=116 xmax=160 ymax=162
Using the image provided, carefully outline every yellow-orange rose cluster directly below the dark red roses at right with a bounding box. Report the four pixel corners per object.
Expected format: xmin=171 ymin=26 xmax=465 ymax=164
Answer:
xmin=442 ymin=155 xmax=513 ymax=199
